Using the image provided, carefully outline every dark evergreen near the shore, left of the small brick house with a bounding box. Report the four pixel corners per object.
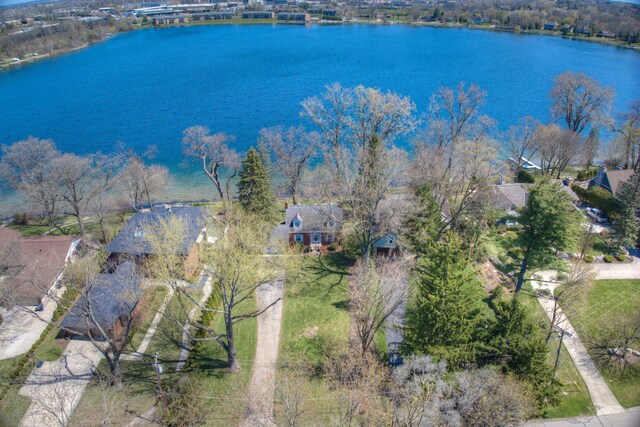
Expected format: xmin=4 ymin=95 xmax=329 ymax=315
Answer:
xmin=238 ymin=147 xmax=275 ymax=220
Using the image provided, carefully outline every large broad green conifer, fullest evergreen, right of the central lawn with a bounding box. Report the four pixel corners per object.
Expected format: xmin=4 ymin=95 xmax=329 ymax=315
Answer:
xmin=406 ymin=232 xmax=483 ymax=366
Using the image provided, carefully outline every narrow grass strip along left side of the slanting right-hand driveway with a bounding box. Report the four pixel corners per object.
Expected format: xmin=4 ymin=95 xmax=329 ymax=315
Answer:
xmin=522 ymin=283 xmax=595 ymax=418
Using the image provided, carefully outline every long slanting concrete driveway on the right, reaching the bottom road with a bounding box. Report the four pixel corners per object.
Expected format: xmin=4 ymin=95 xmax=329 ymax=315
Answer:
xmin=531 ymin=271 xmax=624 ymax=415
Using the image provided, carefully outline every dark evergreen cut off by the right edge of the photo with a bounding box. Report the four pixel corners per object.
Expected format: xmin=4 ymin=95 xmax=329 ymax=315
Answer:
xmin=613 ymin=172 xmax=640 ymax=247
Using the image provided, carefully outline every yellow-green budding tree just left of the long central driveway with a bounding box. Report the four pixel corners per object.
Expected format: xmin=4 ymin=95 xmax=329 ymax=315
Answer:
xmin=145 ymin=210 xmax=286 ymax=372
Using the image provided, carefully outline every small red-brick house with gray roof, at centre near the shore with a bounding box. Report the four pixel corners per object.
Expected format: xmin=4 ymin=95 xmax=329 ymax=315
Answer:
xmin=278 ymin=204 xmax=343 ymax=248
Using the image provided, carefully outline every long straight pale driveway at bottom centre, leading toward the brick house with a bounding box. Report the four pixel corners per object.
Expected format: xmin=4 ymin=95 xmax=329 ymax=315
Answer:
xmin=242 ymin=280 xmax=284 ymax=427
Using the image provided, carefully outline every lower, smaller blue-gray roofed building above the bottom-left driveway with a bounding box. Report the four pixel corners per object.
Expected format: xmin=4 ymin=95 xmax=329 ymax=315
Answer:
xmin=61 ymin=261 xmax=142 ymax=340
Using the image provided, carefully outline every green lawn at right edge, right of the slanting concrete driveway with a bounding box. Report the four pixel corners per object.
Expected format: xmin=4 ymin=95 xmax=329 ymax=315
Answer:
xmin=561 ymin=280 xmax=640 ymax=408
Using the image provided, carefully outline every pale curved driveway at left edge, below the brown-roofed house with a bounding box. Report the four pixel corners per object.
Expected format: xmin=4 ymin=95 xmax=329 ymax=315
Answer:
xmin=0 ymin=288 xmax=64 ymax=360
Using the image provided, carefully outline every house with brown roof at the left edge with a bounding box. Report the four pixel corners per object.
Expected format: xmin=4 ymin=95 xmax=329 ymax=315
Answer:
xmin=0 ymin=228 xmax=80 ymax=306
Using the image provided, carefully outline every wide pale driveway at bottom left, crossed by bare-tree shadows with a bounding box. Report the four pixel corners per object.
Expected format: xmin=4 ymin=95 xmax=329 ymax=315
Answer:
xmin=19 ymin=340 xmax=102 ymax=427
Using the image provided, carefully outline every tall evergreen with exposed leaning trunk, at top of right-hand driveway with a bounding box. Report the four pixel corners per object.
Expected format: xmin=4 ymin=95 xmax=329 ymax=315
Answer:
xmin=516 ymin=182 xmax=581 ymax=293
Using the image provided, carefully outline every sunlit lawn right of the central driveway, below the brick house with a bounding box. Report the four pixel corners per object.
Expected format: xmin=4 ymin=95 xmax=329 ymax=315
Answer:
xmin=276 ymin=253 xmax=352 ymax=425
